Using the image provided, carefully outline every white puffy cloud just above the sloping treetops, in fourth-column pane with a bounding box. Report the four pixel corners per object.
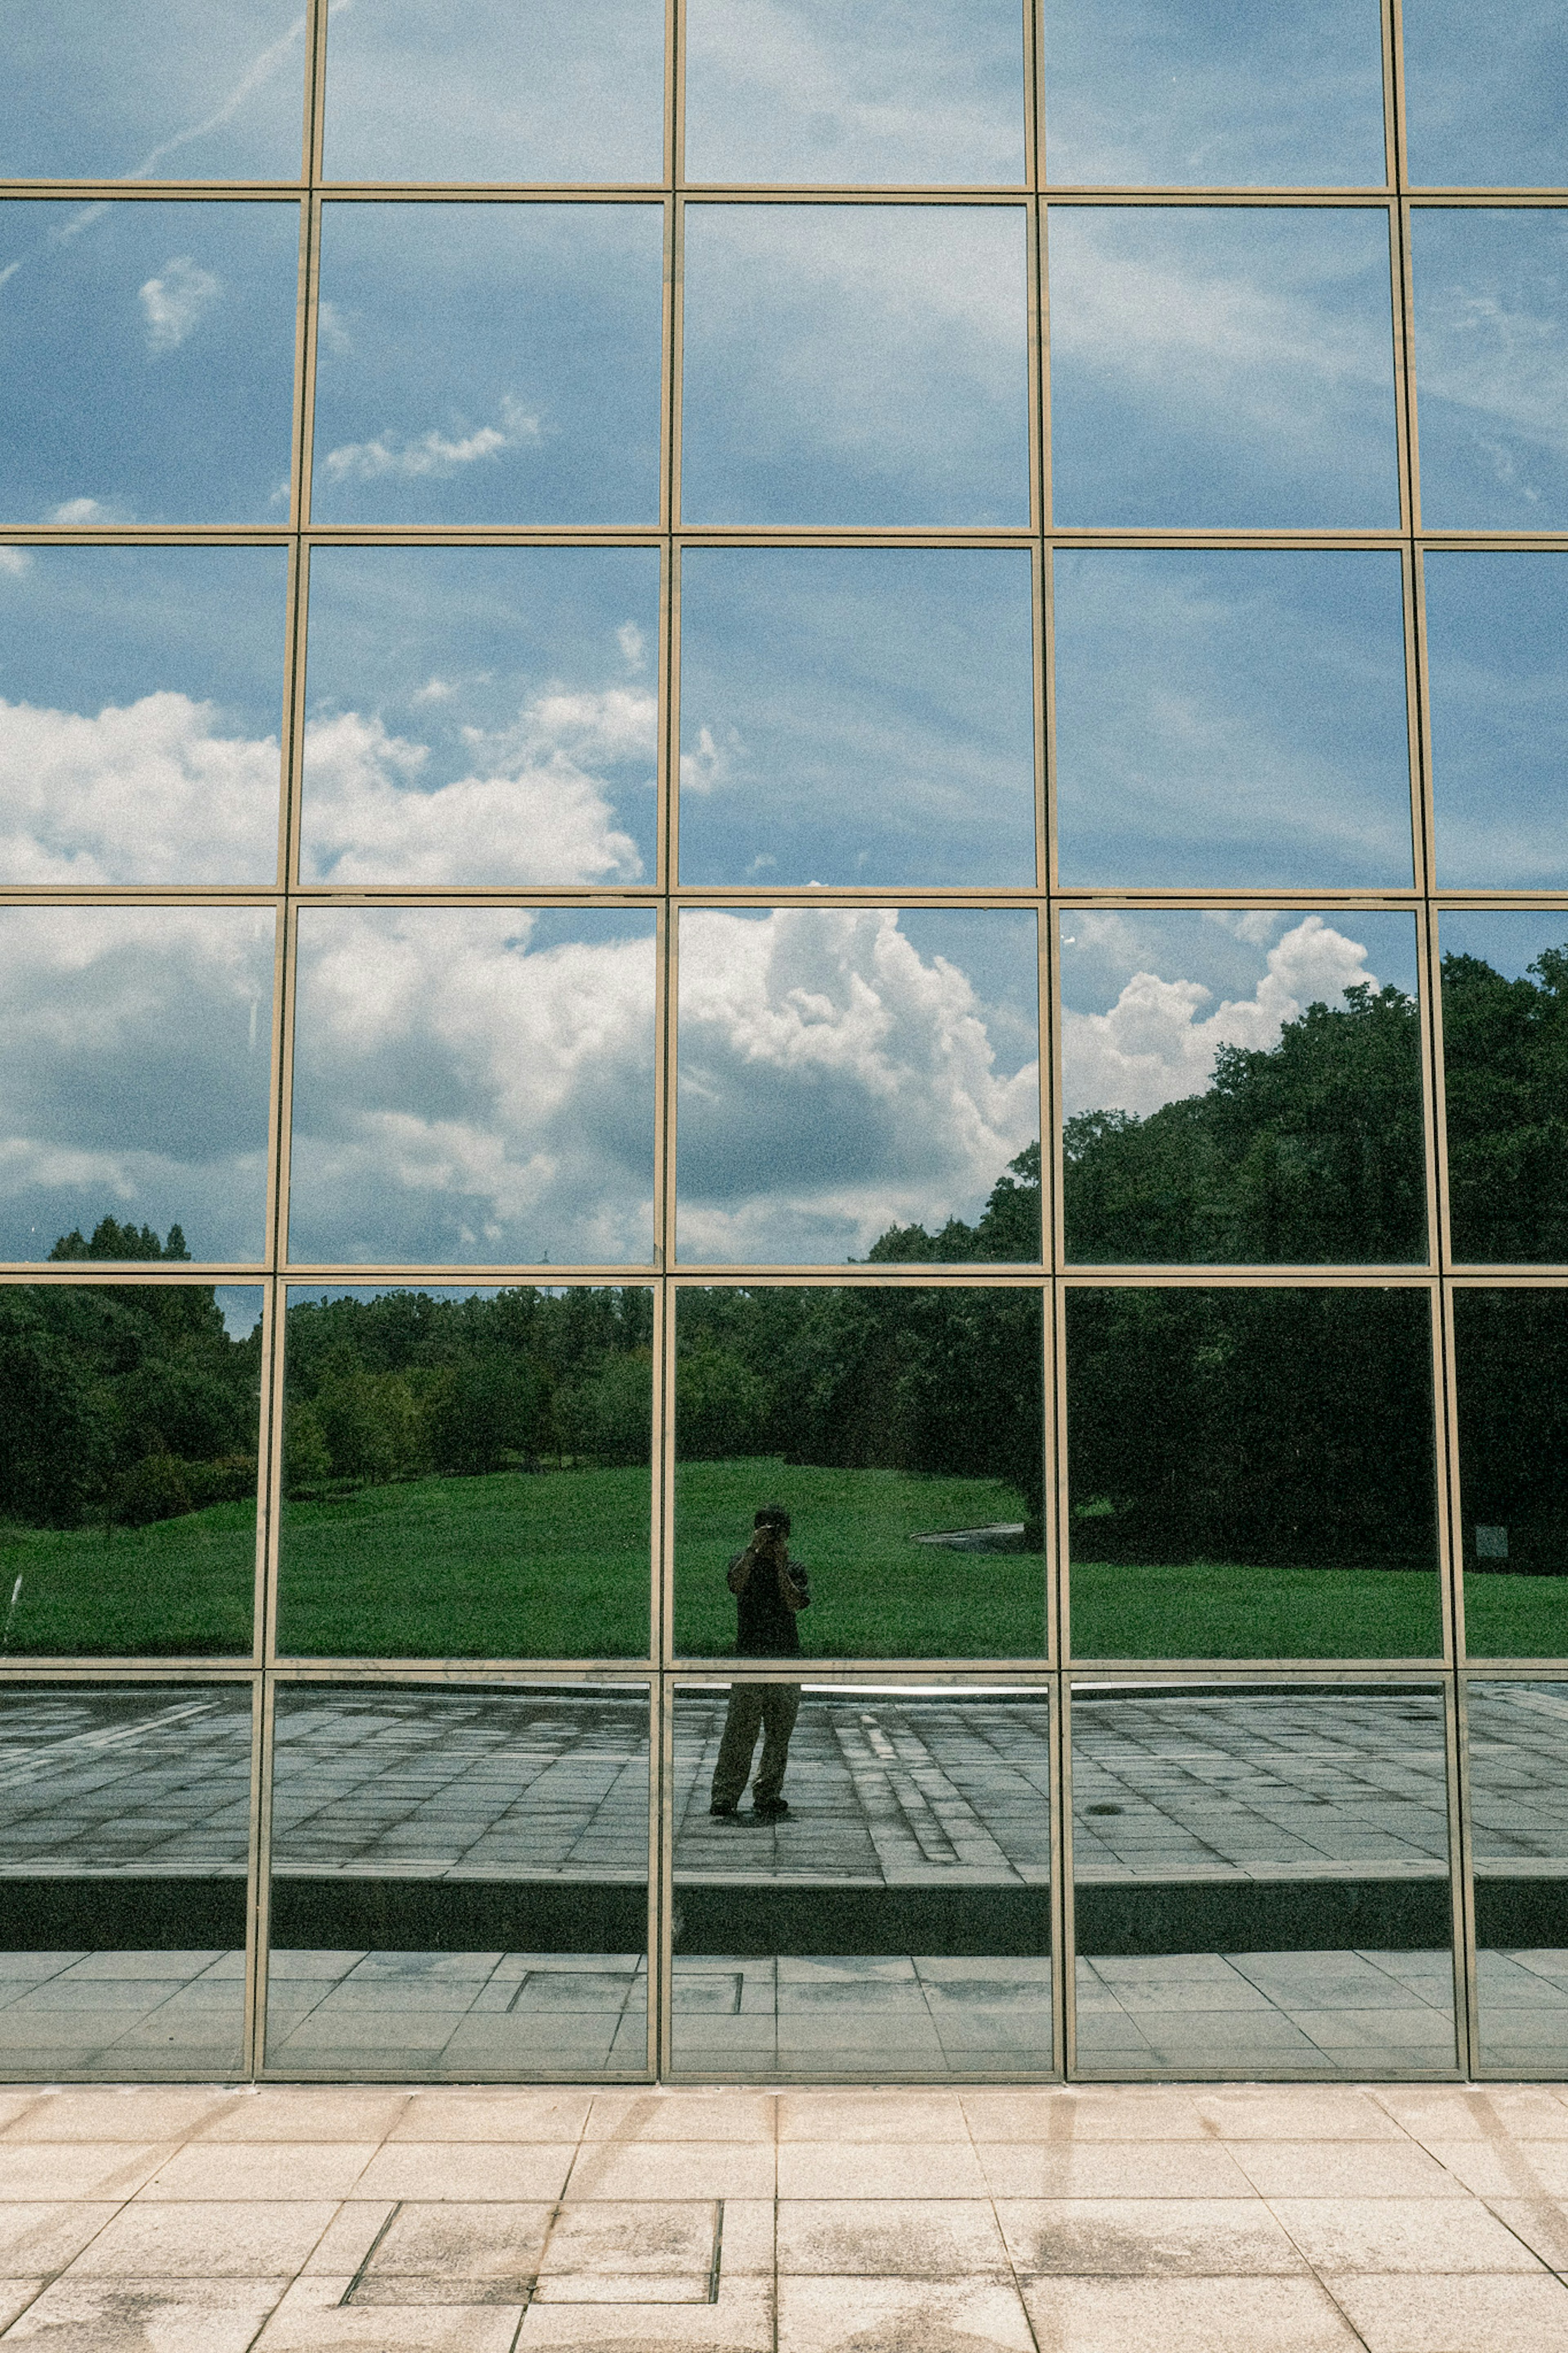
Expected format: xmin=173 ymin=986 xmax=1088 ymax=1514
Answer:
xmin=1062 ymin=915 xmax=1378 ymax=1117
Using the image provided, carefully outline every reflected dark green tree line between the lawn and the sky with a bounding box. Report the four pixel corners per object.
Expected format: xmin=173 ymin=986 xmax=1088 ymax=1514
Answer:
xmin=0 ymin=948 xmax=1568 ymax=1567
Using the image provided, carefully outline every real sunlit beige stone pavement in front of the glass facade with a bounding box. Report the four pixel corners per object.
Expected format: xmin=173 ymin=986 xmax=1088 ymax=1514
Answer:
xmin=0 ymin=2085 xmax=1568 ymax=2353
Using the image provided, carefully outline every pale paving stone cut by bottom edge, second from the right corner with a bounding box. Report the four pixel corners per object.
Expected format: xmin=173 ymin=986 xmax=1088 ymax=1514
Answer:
xmin=1022 ymin=2278 xmax=1361 ymax=2353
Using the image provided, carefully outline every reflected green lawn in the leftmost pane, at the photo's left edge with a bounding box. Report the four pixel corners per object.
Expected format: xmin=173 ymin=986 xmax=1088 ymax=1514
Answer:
xmin=0 ymin=1503 xmax=256 ymax=1657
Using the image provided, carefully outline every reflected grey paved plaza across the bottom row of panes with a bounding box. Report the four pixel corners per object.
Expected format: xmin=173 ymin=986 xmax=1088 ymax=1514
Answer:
xmin=0 ymin=1685 xmax=1568 ymax=2075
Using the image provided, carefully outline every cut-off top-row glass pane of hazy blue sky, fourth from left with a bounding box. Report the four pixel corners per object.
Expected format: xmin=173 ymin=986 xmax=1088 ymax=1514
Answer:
xmin=1046 ymin=0 xmax=1385 ymax=188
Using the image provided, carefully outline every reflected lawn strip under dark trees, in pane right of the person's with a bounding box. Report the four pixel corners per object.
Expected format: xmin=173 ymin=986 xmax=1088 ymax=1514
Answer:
xmin=1069 ymin=1560 xmax=1443 ymax=1659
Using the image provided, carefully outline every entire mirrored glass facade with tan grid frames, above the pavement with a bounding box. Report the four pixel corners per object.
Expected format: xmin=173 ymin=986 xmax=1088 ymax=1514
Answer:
xmin=0 ymin=0 xmax=1568 ymax=2082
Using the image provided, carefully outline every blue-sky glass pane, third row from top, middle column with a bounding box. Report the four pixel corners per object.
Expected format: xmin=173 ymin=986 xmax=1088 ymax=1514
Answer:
xmin=679 ymin=548 xmax=1034 ymax=890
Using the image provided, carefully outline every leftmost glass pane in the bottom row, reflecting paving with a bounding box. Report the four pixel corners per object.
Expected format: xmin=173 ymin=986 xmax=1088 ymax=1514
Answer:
xmin=0 ymin=1682 xmax=252 ymax=2082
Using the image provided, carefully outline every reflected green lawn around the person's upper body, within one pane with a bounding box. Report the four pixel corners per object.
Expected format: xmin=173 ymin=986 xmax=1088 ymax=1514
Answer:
xmin=675 ymin=1459 xmax=1046 ymax=1659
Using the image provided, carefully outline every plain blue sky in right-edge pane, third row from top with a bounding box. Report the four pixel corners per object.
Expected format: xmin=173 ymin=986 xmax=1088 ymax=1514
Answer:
xmin=1425 ymin=548 xmax=1568 ymax=890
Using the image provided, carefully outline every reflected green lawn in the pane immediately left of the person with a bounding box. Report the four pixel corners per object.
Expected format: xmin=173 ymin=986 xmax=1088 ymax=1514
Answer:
xmin=277 ymin=1468 xmax=651 ymax=1659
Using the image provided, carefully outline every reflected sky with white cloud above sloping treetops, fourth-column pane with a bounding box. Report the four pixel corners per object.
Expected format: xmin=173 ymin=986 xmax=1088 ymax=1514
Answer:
xmin=1060 ymin=908 xmax=1415 ymax=1117
